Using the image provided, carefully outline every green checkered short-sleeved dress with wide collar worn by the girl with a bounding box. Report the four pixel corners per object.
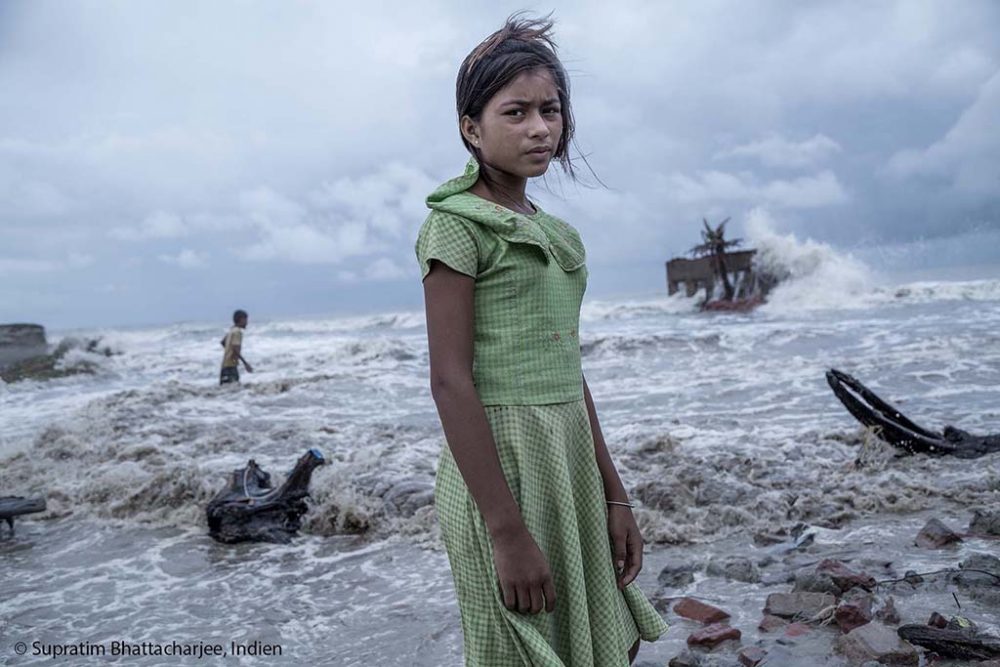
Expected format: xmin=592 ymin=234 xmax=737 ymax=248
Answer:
xmin=416 ymin=160 xmax=667 ymax=667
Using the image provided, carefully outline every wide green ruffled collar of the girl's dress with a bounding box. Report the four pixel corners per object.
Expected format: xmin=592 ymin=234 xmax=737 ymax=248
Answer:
xmin=427 ymin=158 xmax=585 ymax=271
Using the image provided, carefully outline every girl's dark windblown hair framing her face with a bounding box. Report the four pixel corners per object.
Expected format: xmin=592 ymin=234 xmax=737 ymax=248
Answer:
xmin=455 ymin=13 xmax=575 ymax=178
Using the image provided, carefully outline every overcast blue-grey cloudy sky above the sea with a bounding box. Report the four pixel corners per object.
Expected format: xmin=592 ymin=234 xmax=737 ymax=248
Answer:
xmin=0 ymin=0 xmax=1000 ymax=328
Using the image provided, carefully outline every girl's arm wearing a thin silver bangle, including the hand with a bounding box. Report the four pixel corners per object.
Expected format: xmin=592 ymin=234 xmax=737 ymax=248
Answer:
xmin=583 ymin=378 xmax=642 ymax=588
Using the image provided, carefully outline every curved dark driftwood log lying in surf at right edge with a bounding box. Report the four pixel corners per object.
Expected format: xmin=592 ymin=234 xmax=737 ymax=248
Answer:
xmin=826 ymin=368 xmax=1000 ymax=459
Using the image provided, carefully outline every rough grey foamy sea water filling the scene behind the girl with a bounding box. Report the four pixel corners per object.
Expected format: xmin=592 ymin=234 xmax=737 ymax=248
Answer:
xmin=0 ymin=234 xmax=1000 ymax=666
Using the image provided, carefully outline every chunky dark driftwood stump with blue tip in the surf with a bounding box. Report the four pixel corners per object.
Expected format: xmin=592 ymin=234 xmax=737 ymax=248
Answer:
xmin=205 ymin=449 xmax=325 ymax=543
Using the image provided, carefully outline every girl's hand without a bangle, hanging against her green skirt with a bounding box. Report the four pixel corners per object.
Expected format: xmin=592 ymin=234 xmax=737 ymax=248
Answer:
xmin=493 ymin=526 xmax=556 ymax=614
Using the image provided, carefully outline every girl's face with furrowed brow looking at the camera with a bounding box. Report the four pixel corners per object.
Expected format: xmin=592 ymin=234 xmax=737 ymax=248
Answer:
xmin=462 ymin=68 xmax=563 ymax=179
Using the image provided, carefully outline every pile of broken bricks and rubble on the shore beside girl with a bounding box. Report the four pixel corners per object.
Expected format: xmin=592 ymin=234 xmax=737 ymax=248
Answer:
xmin=640 ymin=510 xmax=1000 ymax=667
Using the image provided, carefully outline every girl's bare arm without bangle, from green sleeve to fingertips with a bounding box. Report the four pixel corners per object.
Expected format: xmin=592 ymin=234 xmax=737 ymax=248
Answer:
xmin=424 ymin=261 xmax=555 ymax=613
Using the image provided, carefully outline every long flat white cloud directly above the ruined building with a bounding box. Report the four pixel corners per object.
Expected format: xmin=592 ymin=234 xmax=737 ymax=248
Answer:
xmin=668 ymin=171 xmax=849 ymax=208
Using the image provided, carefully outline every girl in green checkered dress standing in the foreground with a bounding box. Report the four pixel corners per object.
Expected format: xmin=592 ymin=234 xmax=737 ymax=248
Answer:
xmin=416 ymin=15 xmax=666 ymax=667
